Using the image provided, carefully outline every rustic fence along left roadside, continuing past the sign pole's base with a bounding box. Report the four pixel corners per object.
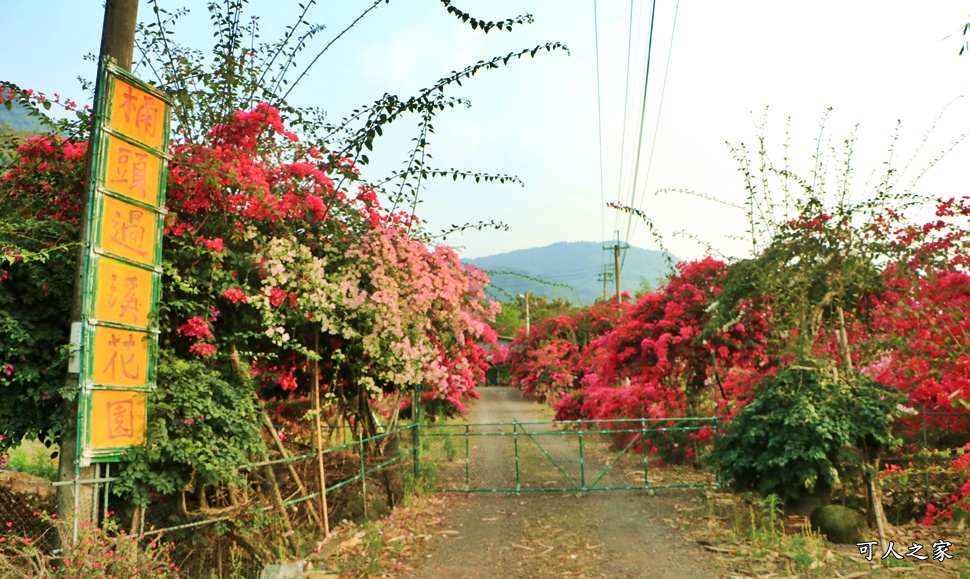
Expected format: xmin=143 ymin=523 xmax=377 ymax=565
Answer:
xmin=0 ymin=426 xmax=416 ymax=579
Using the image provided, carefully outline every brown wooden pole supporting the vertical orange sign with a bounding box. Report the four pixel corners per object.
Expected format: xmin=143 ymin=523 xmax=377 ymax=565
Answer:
xmin=57 ymin=0 xmax=138 ymax=540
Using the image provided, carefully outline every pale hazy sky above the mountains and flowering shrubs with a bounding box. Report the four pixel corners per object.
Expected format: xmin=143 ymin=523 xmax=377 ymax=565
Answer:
xmin=0 ymin=0 xmax=970 ymax=282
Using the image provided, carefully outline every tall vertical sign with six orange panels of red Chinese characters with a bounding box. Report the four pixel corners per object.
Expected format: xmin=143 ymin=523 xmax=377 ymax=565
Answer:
xmin=78 ymin=61 xmax=170 ymax=466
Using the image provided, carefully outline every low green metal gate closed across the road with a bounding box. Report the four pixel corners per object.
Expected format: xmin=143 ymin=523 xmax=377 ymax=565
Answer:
xmin=419 ymin=418 xmax=717 ymax=492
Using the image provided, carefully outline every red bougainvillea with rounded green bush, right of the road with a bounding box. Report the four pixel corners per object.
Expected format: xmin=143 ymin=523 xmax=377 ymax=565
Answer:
xmin=500 ymin=114 xmax=970 ymax=520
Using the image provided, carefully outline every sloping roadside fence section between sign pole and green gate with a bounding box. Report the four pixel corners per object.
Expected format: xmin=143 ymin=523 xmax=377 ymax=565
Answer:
xmin=140 ymin=427 xmax=414 ymax=578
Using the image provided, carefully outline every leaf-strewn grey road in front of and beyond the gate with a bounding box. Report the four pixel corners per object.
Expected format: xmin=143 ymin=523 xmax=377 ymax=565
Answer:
xmin=396 ymin=387 xmax=722 ymax=579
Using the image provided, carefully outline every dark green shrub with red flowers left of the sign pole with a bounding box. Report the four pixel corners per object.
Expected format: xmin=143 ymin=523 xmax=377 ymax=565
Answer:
xmin=0 ymin=136 xmax=87 ymax=451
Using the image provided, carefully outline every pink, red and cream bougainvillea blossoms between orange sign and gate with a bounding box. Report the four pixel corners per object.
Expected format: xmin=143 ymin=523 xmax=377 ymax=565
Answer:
xmin=158 ymin=105 xmax=495 ymax=422
